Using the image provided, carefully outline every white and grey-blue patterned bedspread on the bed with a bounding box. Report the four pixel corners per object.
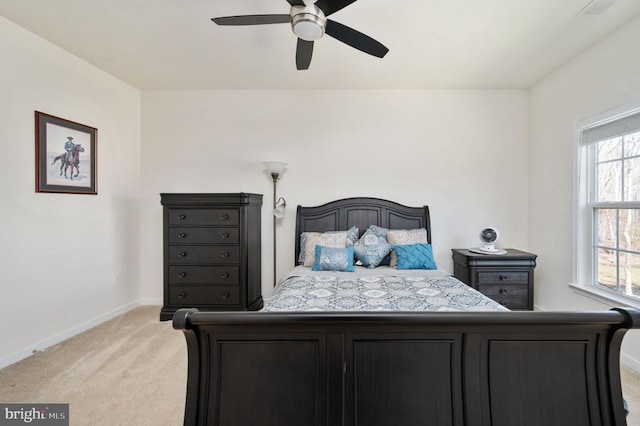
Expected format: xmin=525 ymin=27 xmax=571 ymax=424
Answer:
xmin=262 ymin=266 xmax=508 ymax=312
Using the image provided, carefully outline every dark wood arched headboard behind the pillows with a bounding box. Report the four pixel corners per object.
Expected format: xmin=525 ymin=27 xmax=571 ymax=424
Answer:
xmin=294 ymin=197 xmax=431 ymax=265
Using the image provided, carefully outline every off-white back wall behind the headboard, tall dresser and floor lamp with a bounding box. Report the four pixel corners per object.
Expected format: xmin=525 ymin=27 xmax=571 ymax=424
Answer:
xmin=141 ymin=90 xmax=528 ymax=302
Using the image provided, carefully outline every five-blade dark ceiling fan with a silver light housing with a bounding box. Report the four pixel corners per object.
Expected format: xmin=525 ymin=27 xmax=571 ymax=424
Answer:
xmin=211 ymin=0 xmax=389 ymax=70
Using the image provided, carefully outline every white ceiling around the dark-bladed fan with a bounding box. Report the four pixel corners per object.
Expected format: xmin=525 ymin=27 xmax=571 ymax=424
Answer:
xmin=0 ymin=0 xmax=640 ymax=90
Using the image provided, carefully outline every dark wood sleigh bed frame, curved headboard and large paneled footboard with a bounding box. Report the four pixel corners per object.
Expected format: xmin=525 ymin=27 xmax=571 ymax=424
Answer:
xmin=173 ymin=198 xmax=640 ymax=426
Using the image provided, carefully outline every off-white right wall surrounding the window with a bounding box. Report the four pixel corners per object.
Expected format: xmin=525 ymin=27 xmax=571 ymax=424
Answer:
xmin=529 ymin=15 xmax=640 ymax=368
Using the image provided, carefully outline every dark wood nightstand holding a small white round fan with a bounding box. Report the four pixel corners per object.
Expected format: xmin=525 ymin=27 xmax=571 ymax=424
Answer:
xmin=451 ymin=249 xmax=537 ymax=310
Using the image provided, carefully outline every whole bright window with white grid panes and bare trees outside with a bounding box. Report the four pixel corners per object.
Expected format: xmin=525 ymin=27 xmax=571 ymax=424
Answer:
xmin=577 ymin=110 xmax=640 ymax=301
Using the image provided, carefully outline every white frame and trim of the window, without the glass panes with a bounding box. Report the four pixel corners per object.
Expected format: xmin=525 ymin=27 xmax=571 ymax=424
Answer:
xmin=569 ymin=99 xmax=640 ymax=308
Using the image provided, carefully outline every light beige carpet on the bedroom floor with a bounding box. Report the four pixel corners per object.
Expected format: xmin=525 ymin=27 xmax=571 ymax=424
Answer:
xmin=0 ymin=306 xmax=640 ymax=426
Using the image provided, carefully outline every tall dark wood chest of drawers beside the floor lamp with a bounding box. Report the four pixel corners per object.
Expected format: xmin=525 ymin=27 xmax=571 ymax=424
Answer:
xmin=160 ymin=193 xmax=263 ymax=321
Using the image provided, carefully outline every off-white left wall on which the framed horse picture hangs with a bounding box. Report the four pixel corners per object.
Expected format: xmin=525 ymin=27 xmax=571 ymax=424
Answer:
xmin=0 ymin=17 xmax=140 ymax=367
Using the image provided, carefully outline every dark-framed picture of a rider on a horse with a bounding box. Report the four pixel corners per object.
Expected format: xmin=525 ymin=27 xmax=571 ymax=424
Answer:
xmin=36 ymin=111 xmax=98 ymax=195
